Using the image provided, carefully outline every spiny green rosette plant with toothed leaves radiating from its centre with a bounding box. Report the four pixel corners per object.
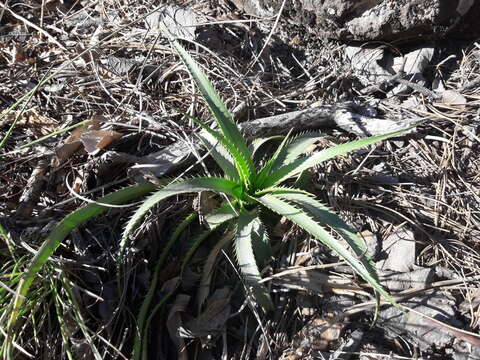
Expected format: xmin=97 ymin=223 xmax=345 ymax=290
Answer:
xmin=122 ymin=40 xmax=404 ymax=310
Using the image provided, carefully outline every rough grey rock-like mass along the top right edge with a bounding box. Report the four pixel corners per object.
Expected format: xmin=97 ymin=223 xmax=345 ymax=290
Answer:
xmin=240 ymin=0 xmax=480 ymax=42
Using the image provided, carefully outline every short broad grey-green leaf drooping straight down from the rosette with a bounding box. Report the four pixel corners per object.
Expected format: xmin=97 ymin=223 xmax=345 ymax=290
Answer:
xmin=234 ymin=209 xmax=273 ymax=311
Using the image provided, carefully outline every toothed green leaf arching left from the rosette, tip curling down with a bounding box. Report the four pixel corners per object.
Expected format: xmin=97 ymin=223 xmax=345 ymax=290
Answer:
xmin=120 ymin=177 xmax=242 ymax=255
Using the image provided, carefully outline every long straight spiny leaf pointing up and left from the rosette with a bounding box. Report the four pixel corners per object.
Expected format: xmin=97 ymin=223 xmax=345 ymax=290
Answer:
xmin=172 ymin=40 xmax=255 ymax=182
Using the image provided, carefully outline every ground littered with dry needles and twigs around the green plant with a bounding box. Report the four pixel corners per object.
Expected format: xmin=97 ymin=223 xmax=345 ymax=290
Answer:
xmin=0 ymin=0 xmax=480 ymax=360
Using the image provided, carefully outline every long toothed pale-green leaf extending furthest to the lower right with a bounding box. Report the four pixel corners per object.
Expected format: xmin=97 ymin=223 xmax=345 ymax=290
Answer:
xmin=255 ymin=194 xmax=395 ymax=304
